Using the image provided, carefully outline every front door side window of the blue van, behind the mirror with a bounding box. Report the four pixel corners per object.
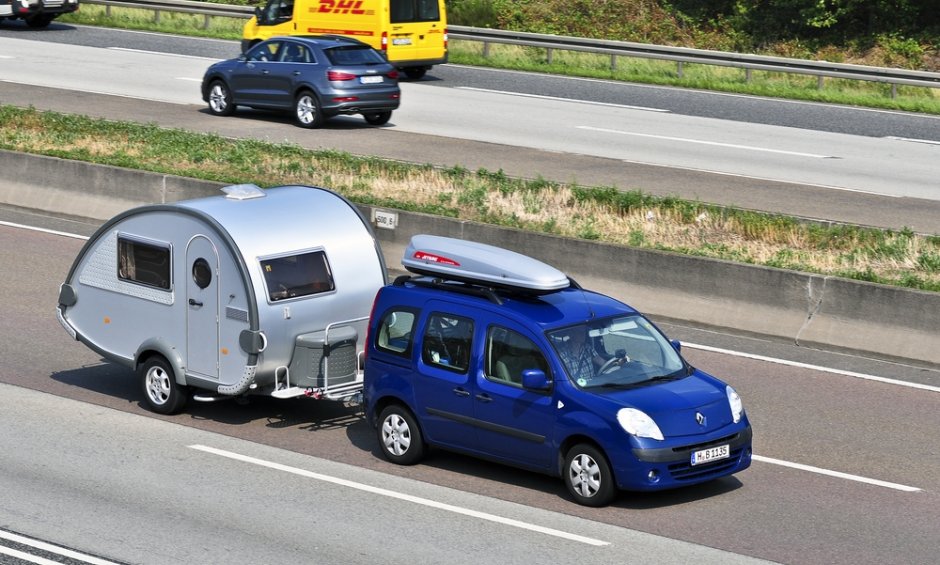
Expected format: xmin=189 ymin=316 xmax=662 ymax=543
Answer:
xmin=483 ymin=326 xmax=548 ymax=387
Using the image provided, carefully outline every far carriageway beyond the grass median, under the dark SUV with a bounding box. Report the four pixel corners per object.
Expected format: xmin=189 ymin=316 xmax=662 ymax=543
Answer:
xmin=0 ymin=22 xmax=940 ymax=233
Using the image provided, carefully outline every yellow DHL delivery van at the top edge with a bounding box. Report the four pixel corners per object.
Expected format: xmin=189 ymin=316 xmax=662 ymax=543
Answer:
xmin=242 ymin=0 xmax=447 ymax=80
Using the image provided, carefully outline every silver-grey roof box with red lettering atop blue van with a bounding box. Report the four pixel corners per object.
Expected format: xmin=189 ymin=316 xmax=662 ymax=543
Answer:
xmin=401 ymin=234 xmax=571 ymax=294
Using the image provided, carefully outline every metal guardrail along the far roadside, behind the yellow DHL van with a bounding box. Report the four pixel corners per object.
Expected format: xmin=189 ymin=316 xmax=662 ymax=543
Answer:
xmin=81 ymin=0 xmax=940 ymax=98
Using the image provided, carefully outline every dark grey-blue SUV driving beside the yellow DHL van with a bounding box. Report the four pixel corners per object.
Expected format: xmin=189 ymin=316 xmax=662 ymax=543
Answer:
xmin=202 ymin=35 xmax=401 ymax=128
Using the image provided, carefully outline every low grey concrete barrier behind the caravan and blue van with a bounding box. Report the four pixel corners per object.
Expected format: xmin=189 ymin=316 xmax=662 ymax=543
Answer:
xmin=0 ymin=151 xmax=940 ymax=366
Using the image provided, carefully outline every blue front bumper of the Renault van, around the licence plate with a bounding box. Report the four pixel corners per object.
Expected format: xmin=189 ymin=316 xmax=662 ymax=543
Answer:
xmin=611 ymin=424 xmax=753 ymax=491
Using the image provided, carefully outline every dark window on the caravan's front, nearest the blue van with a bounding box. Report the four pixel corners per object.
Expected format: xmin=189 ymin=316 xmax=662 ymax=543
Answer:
xmin=261 ymin=247 xmax=336 ymax=302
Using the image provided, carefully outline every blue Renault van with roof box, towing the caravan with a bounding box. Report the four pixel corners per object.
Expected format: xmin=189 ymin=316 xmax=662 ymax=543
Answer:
xmin=363 ymin=235 xmax=752 ymax=506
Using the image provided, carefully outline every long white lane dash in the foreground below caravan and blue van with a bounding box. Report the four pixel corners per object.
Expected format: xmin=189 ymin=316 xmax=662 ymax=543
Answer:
xmin=189 ymin=445 xmax=610 ymax=546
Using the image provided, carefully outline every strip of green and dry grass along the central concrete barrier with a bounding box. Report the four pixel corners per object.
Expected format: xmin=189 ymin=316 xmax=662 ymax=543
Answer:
xmin=0 ymin=105 xmax=940 ymax=292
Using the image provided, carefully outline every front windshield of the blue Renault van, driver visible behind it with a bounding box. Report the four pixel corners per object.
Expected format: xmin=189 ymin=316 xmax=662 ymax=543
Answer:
xmin=548 ymin=314 xmax=689 ymax=390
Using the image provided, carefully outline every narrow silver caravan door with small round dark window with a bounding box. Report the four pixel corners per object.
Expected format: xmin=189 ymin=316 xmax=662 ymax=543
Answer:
xmin=186 ymin=235 xmax=219 ymax=380
